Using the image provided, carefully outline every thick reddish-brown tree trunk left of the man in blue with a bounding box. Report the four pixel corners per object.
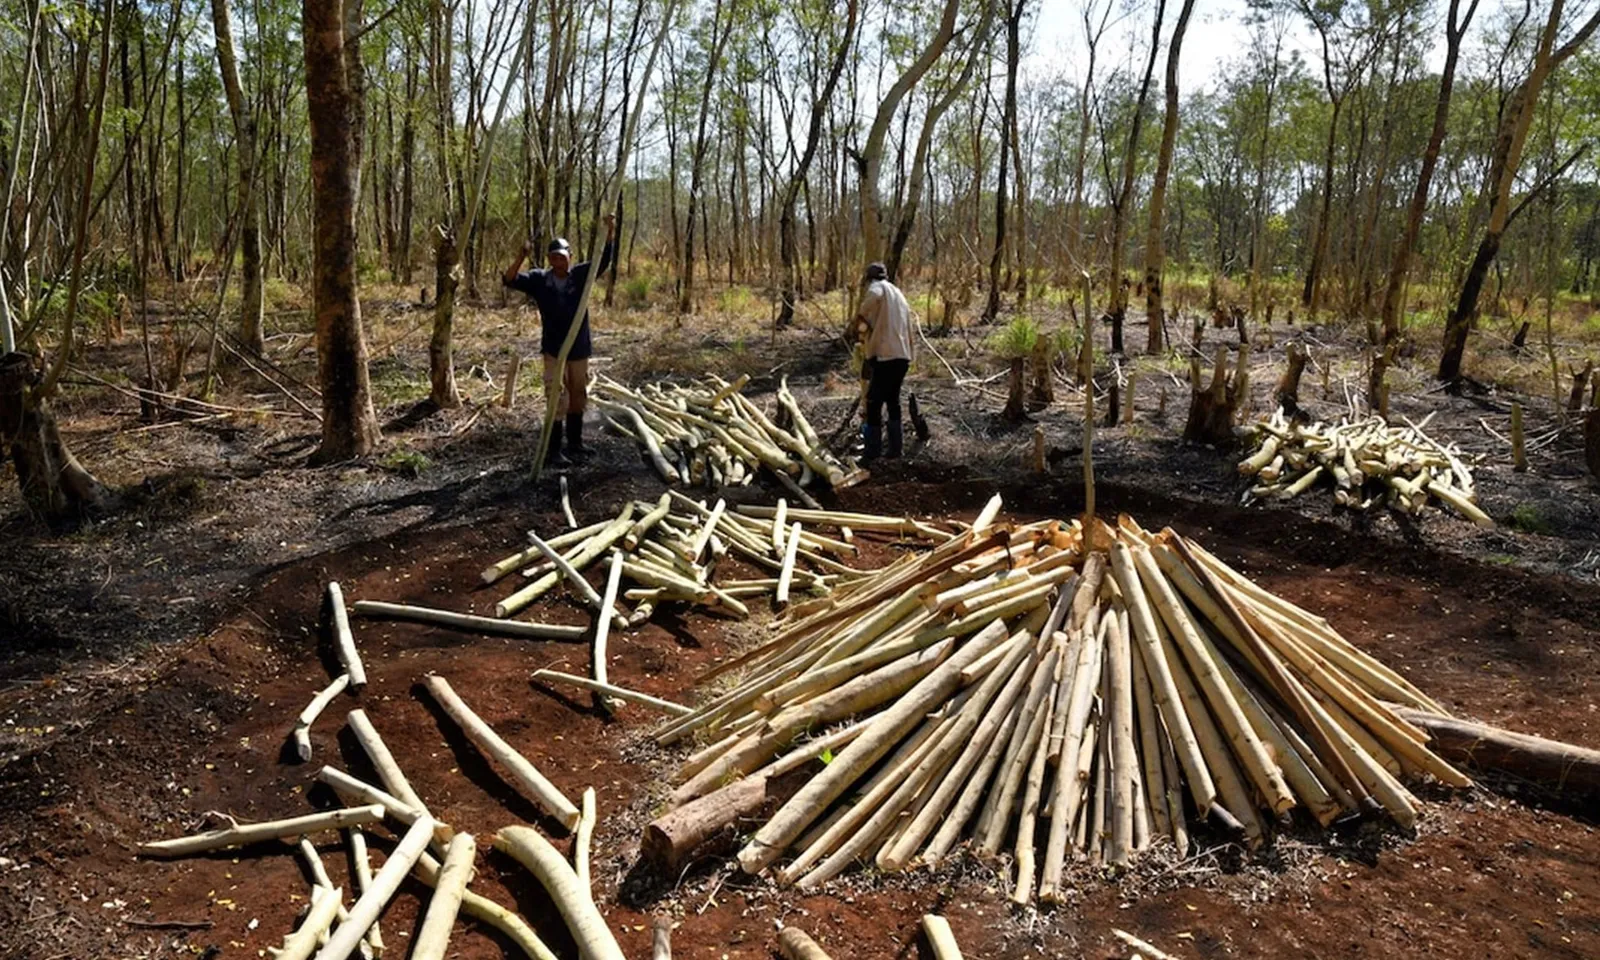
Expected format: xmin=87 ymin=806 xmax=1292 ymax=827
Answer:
xmin=301 ymin=0 xmax=378 ymax=462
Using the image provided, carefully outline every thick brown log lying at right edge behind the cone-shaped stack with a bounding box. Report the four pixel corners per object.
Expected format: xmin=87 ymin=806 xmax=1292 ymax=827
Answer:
xmin=1392 ymin=706 xmax=1600 ymax=800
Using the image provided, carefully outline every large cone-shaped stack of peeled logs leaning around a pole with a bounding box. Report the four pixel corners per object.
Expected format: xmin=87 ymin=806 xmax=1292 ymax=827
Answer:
xmin=645 ymin=501 xmax=1470 ymax=902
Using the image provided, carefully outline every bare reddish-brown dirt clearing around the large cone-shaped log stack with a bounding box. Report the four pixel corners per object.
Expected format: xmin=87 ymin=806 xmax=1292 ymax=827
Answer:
xmin=0 ymin=477 xmax=1600 ymax=960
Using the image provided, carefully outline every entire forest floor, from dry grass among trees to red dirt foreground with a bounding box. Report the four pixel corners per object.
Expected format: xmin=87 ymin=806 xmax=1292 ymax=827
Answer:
xmin=0 ymin=272 xmax=1600 ymax=958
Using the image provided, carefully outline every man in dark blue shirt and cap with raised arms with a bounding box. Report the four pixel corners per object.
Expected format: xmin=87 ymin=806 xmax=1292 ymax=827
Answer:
xmin=501 ymin=213 xmax=616 ymax=467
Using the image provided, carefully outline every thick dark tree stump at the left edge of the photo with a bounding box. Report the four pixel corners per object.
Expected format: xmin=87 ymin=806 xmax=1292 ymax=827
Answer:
xmin=0 ymin=354 xmax=110 ymax=523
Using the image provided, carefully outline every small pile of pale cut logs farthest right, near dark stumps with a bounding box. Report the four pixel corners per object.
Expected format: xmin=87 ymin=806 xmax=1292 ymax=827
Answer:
xmin=1238 ymin=410 xmax=1494 ymax=526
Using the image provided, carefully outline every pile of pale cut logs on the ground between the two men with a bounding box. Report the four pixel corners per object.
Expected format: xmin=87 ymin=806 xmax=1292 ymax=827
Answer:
xmin=594 ymin=374 xmax=866 ymax=499
